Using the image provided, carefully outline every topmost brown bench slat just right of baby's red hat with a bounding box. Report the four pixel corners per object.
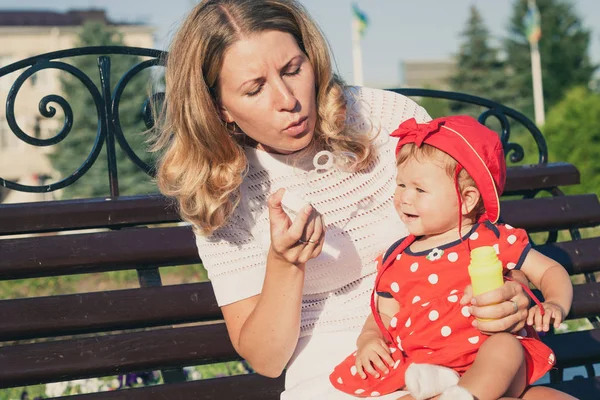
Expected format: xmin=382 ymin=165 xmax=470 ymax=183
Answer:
xmin=504 ymin=162 xmax=580 ymax=195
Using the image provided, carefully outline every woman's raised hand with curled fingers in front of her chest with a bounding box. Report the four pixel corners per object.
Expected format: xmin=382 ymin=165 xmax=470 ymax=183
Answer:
xmin=268 ymin=189 xmax=325 ymax=265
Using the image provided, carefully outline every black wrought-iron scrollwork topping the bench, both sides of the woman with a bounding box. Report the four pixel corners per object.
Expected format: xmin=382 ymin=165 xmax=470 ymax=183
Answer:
xmin=0 ymin=46 xmax=548 ymax=195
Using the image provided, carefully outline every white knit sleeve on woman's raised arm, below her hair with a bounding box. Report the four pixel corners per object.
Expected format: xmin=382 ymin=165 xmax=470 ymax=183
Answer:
xmin=196 ymin=214 xmax=267 ymax=306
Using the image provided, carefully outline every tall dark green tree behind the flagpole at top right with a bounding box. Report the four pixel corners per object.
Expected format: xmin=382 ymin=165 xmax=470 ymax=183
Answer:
xmin=504 ymin=0 xmax=597 ymax=116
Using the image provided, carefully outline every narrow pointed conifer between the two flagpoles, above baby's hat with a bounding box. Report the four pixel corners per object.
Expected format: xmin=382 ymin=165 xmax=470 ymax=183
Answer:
xmin=449 ymin=6 xmax=511 ymax=116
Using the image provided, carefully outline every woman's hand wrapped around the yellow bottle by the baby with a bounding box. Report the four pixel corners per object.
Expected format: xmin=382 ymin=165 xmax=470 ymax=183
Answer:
xmin=460 ymin=270 xmax=529 ymax=334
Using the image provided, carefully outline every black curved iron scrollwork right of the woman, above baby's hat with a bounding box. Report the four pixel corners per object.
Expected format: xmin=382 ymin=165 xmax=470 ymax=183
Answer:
xmin=390 ymin=88 xmax=548 ymax=164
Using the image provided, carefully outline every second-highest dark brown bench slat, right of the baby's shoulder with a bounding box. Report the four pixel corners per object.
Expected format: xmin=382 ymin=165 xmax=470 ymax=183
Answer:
xmin=501 ymin=194 xmax=600 ymax=233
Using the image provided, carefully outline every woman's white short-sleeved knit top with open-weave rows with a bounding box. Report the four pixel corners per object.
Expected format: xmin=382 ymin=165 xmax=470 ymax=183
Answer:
xmin=196 ymin=88 xmax=430 ymax=337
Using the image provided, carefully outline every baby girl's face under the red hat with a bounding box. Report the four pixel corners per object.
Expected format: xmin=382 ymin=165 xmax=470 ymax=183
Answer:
xmin=394 ymin=158 xmax=458 ymax=236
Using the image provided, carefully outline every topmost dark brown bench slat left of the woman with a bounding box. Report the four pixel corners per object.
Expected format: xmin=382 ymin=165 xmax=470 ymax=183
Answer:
xmin=0 ymin=194 xmax=181 ymax=235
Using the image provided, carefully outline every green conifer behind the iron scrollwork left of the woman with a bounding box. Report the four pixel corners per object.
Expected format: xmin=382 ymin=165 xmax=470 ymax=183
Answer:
xmin=50 ymin=22 xmax=156 ymax=198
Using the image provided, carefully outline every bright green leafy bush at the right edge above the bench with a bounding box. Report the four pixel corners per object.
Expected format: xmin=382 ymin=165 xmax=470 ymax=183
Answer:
xmin=544 ymin=86 xmax=600 ymax=195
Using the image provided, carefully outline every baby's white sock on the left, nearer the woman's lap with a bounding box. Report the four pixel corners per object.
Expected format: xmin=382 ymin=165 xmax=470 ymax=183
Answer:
xmin=404 ymin=364 xmax=459 ymax=400
